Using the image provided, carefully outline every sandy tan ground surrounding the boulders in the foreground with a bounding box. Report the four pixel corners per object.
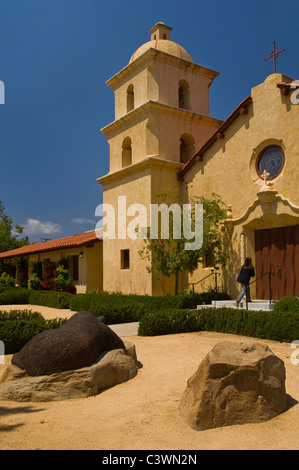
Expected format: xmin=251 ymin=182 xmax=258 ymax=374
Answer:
xmin=0 ymin=328 xmax=299 ymax=450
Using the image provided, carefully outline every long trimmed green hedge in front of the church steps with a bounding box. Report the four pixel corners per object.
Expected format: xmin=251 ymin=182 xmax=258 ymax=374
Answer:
xmin=138 ymin=308 xmax=299 ymax=342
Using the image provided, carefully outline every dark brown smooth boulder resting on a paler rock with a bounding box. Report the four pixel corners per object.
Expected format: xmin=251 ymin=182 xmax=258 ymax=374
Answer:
xmin=12 ymin=312 xmax=125 ymax=376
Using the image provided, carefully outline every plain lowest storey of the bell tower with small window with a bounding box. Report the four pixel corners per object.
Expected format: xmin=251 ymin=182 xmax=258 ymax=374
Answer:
xmin=103 ymin=161 xmax=188 ymax=295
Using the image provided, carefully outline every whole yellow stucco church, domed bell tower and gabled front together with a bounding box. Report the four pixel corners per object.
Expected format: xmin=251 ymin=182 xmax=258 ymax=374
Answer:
xmin=98 ymin=23 xmax=299 ymax=298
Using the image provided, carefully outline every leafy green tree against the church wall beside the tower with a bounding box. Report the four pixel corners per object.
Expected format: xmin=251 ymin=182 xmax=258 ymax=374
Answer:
xmin=139 ymin=188 xmax=227 ymax=294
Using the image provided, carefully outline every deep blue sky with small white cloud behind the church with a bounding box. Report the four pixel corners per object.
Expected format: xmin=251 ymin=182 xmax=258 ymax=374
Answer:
xmin=0 ymin=0 xmax=299 ymax=242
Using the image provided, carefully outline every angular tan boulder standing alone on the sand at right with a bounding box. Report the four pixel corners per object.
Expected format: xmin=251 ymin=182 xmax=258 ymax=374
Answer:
xmin=179 ymin=342 xmax=286 ymax=430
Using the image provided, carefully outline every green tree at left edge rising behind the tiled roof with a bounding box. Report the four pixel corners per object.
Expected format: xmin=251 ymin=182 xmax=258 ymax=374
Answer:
xmin=0 ymin=201 xmax=29 ymax=253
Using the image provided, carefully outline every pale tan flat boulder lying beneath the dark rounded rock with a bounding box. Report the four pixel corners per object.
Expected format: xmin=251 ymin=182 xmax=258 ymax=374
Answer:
xmin=0 ymin=342 xmax=139 ymax=402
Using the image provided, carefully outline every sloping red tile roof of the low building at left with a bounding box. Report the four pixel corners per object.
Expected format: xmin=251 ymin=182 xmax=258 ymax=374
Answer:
xmin=0 ymin=230 xmax=102 ymax=259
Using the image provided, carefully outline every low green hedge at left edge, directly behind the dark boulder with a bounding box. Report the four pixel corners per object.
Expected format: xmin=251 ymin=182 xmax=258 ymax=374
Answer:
xmin=0 ymin=310 xmax=65 ymax=354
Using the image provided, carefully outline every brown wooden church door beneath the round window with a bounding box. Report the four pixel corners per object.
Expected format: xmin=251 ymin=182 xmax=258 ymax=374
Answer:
xmin=255 ymin=225 xmax=299 ymax=300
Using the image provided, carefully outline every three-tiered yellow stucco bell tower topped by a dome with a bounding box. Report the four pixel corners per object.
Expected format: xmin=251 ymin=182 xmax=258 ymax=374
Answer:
xmin=98 ymin=22 xmax=222 ymax=295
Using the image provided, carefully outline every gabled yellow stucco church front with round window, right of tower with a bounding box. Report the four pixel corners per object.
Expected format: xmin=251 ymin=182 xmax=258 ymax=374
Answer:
xmin=182 ymin=74 xmax=299 ymax=298
